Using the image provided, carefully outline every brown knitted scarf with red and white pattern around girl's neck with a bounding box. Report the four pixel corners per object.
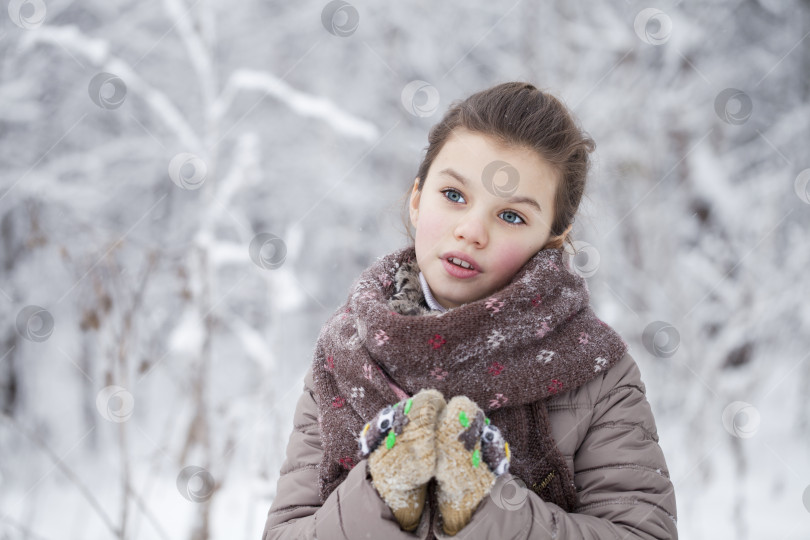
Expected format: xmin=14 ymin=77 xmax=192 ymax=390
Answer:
xmin=313 ymin=246 xmax=627 ymax=512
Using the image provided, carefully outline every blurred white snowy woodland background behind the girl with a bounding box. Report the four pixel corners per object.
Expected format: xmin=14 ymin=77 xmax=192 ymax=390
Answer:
xmin=0 ymin=0 xmax=810 ymax=540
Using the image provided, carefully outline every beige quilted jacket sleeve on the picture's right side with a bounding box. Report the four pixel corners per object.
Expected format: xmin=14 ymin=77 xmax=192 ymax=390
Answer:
xmin=436 ymin=354 xmax=678 ymax=540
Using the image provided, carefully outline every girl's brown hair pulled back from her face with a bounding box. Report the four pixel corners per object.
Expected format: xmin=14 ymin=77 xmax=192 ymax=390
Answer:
xmin=403 ymin=82 xmax=596 ymax=251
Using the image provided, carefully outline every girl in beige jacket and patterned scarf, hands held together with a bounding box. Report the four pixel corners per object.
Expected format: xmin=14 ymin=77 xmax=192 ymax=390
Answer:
xmin=263 ymin=82 xmax=677 ymax=540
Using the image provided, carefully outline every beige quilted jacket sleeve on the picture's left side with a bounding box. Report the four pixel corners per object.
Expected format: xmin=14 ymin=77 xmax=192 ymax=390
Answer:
xmin=262 ymin=368 xmax=430 ymax=540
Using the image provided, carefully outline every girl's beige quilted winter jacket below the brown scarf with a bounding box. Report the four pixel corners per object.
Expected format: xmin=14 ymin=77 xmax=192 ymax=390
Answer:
xmin=262 ymin=353 xmax=678 ymax=540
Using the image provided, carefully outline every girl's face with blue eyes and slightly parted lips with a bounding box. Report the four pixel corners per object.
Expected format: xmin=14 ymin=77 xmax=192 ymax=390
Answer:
xmin=410 ymin=129 xmax=557 ymax=309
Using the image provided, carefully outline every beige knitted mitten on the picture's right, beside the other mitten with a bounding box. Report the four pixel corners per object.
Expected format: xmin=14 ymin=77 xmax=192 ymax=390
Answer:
xmin=436 ymin=396 xmax=511 ymax=536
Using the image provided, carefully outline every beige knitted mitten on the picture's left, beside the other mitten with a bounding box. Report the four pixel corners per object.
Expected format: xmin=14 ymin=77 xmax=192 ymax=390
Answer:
xmin=357 ymin=389 xmax=445 ymax=531
